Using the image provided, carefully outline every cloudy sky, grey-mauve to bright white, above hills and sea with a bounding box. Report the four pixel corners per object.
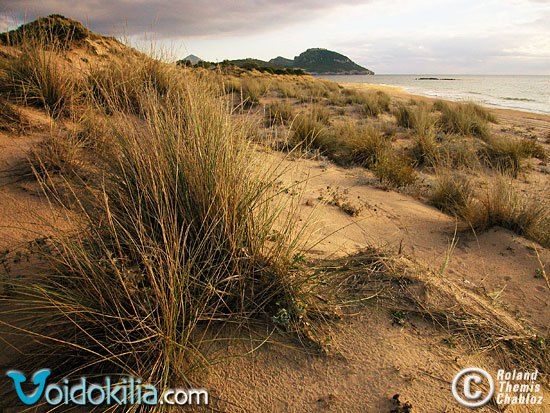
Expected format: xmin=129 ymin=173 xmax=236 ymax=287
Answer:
xmin=0 ymin=0 xmax=550 ymax=75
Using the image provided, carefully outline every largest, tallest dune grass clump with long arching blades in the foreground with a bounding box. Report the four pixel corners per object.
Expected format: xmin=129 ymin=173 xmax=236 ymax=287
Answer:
xmin=3 ymin=62 xmax=313 ymax=391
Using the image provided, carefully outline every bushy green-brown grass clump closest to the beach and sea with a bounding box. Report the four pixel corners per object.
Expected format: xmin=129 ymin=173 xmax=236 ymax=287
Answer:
xmin=433 ymin=101 xmax=496 ymax=140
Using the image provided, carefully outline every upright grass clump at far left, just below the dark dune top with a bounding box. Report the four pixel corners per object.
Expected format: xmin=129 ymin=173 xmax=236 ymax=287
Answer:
xmin=0 ymin=39 xmax=77 ymax=116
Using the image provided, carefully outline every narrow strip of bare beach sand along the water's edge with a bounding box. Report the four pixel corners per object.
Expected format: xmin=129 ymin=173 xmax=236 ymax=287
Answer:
xmin=336 ymin=82 xmax=550 ymax=122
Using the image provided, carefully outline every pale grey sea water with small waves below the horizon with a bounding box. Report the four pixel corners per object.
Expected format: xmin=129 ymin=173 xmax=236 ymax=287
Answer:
xmin=316 ymin=75 xmax=550 ymax=114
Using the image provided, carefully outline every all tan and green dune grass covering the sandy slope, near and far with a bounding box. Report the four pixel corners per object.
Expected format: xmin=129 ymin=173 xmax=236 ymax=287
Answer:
xmin=0 ymin=16 xmax=550 ymax=408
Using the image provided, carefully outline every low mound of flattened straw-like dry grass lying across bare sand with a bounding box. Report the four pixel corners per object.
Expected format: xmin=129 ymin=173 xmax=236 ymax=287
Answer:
xmin=319 ymin=248 xmax=550 ymax=374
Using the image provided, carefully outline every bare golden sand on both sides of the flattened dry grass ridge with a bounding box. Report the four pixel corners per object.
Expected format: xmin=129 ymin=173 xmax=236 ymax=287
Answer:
xmin=205 ymin=150 xmax=550 ymax=412
